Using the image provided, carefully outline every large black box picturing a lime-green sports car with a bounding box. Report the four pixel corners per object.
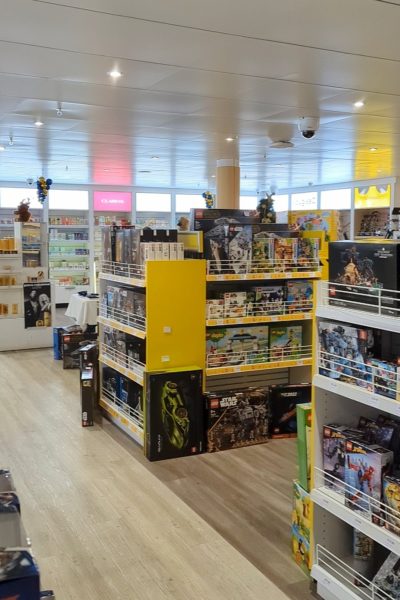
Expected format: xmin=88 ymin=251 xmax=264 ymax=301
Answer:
xmin=145 ymin=369 xmax=204 ymax=460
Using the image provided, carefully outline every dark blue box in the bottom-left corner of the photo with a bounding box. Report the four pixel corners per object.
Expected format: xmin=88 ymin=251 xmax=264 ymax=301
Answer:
xmin=0 ymin=548 xmax=40 ymax=600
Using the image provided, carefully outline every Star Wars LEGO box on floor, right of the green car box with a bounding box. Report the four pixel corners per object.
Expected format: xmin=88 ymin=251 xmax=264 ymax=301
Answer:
xmin=206 ymin=388 xmax=269 ymax=452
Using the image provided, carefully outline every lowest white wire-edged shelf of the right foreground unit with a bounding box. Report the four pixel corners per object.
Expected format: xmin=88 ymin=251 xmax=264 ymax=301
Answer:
xmin=311 ymin=544 xmax=393 ymax=600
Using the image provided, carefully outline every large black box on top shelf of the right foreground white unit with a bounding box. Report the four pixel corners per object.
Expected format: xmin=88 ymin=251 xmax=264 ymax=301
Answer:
xmin=329 ymin=240 xmax=400 ymax=316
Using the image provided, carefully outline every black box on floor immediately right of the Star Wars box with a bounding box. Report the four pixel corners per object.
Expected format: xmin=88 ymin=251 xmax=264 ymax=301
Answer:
xmin=269 ymin=383 xmax=311 ymax=438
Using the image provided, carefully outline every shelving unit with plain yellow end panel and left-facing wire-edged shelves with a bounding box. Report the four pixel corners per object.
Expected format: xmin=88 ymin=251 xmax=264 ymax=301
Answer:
xmin=98 ymin=260 xmax=206 ymax=445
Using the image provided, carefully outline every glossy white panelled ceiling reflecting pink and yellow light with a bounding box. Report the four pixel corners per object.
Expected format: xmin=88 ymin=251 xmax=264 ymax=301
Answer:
xmin=0 ymin=0 xmax=400 ymax=191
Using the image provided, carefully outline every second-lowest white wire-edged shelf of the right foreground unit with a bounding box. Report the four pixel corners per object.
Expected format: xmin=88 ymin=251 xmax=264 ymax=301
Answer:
xmin=311 ymin=467 xmax=400 ymax=555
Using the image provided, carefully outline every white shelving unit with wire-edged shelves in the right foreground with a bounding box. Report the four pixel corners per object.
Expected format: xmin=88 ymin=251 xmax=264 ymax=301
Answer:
xmin=311 ymin=282 xmax=400 ymax=600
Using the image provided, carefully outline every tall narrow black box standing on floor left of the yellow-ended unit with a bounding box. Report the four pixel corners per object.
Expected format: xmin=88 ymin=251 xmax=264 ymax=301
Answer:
xmin=79 ymin=343 xmax=99 ymax=427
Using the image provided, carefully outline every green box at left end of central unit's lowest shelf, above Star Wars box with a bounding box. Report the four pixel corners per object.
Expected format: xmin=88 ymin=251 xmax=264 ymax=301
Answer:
xmin=206 ymin=325 xmax=269 ymax=368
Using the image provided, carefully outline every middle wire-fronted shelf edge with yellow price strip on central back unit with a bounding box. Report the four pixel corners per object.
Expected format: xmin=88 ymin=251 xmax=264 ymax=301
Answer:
xmin=207 ymin=300 xmax=313 ymax=327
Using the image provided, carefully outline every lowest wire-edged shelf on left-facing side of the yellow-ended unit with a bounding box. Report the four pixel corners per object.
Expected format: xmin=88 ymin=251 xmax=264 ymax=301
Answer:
xmin=99 ymin=387 xmax=144 ymax=446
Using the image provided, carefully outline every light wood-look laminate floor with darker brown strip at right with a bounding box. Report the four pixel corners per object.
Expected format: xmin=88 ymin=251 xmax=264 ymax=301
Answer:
xmin=0 ymin=350 xmax=309 ymax=600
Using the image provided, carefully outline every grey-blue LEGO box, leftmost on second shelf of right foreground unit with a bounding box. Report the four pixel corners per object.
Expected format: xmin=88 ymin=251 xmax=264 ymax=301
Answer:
xmin=318 ymin=321 xmax=374 ymax=391
